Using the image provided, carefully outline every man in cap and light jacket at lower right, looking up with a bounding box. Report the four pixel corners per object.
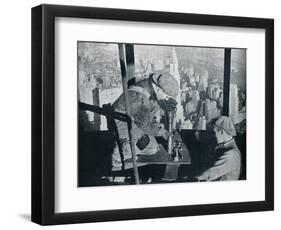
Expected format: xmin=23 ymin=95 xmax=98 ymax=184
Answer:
xmin=197 ymin=116 xmax=241 ymax=181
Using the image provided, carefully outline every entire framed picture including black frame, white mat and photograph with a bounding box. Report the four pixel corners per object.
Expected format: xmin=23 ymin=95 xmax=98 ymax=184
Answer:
xmin=29 ymin=2 xmax=275 ymax=228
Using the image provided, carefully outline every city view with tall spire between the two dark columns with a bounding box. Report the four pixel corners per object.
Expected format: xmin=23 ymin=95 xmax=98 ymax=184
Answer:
xmin=134 ymin=45 xmax=224 ymax=130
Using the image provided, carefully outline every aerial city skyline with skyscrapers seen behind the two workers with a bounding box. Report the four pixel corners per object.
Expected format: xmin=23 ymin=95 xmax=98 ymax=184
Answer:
xmin=78 ymin=42 xmax=246 ymax=130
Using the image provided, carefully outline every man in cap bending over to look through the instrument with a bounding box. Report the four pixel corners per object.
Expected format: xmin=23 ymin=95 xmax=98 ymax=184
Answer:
xmin=112 ymin=73 xmax=179 ymax=167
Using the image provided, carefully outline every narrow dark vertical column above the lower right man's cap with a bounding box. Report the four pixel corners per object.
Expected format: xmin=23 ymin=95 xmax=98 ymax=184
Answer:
xmin=222 ymin=48 xmax=231 ymax=116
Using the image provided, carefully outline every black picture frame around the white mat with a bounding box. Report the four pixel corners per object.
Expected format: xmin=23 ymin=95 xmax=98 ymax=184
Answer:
xmin=31 ymin=5 xmax=274 ymax=225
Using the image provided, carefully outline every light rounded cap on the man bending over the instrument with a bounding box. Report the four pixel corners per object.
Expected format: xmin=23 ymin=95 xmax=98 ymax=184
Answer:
xmin=153 ymin=73 xmax=179 ymax=97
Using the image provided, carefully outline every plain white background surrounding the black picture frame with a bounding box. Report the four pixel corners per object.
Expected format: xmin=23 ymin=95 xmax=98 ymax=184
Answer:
xmin=0 ymin=0 xmax=281 ymax=230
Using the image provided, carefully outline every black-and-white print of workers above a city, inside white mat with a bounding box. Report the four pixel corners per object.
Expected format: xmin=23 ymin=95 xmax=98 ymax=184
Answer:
xmin=77 ymin=41 xmax=247 ymax=187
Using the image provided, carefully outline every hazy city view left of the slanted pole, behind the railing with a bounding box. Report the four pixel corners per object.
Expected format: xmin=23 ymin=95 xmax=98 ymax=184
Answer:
xmin=78 ymin=42 xmax=122 ymax=131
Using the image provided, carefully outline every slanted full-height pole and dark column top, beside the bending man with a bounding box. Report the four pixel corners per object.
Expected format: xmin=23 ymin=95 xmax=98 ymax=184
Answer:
xmin=118 ymin=44 xmax=140 ymax=184
